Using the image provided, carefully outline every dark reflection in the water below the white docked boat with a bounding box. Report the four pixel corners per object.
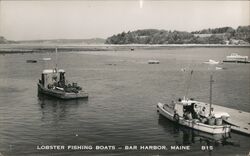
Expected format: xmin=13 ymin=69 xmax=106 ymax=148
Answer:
xmin=158 ymin=115 xmax=240 ymax=147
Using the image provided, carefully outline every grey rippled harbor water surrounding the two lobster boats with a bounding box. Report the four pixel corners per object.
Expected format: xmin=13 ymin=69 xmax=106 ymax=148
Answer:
xmin=0 ymin=47 xmax=250 ymax=156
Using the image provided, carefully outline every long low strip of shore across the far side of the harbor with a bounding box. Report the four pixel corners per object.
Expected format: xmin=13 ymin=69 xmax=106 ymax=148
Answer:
xmin=0 ymin=44 xmax=250 ymax=54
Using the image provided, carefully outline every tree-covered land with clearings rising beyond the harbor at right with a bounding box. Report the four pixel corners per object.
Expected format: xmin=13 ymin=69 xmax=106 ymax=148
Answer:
xmin=105 ymin=26 xmax=250 ymax=45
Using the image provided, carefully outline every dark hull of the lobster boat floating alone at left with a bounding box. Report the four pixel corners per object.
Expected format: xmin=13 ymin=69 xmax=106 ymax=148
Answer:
xmin=37 ymin=83 xmax=88 ymax=99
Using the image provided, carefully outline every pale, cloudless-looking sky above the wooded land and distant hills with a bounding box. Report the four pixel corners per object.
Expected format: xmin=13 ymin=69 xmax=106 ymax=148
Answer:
xmin=0 ymin=0 xmax=250 ymax=40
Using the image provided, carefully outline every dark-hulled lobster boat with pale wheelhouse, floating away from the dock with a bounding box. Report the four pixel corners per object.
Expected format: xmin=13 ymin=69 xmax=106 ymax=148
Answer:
xmin=37 ymin=50 xmax=88 ymax=99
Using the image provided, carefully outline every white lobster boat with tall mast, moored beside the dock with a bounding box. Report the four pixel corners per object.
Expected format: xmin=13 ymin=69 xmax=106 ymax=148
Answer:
xmin=157 ymin=72 xmax=231 ymax=134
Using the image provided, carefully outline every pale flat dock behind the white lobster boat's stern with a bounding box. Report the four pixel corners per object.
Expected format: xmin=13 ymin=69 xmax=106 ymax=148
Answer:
xmin=212 ymin=104 xmax=250 ymax=135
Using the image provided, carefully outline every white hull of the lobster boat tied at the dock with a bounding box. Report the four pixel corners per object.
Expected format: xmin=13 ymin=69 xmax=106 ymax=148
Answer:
xmin=157 ymin=103 xmax=231 ymax=134
